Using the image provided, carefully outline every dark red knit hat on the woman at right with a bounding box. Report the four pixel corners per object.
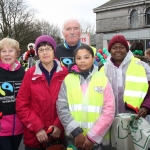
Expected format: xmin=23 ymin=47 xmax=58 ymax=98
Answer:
xmin=108 ymin=35 xmax=129 ymax=52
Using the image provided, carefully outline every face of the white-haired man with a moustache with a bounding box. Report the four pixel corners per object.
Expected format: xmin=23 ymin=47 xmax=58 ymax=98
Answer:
xmin=62 ymin=20 xmax=81 ymax=46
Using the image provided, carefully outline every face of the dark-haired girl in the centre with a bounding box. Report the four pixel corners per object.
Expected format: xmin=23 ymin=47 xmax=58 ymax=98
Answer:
xmin=75 ymin=49 xmax=94 ymax=71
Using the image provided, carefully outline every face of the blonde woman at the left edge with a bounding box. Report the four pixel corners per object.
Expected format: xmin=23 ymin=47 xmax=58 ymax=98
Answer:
xmin=0 ymin=45 xmax=18 ymax=67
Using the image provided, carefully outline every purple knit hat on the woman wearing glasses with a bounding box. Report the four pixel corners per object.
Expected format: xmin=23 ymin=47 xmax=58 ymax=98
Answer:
xmin=35 ymin=35 xmax=56 ymax=54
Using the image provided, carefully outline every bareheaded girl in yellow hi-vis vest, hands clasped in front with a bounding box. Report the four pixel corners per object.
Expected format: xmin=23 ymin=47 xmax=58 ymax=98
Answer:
xmin=57 ymin=45 xmax=115 ymax=150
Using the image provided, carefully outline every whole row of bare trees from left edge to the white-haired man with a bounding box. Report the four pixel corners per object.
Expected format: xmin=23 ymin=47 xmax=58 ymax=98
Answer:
xmin=0 ymin=0 xmax=61 ymax=53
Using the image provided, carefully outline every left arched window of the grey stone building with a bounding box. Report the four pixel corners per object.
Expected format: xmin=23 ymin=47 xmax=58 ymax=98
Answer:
xmin=130 ymin=10 xmax=139 ymax=28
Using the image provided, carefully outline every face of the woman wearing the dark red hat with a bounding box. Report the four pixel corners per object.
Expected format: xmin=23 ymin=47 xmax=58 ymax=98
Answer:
xmin=110 ymin=43 xmax=128 ymax=65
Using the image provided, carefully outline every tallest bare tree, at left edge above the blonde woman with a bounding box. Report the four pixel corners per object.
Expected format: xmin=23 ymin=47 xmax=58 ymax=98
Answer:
xmin=0 ymin=0 xmax=40 ymax=51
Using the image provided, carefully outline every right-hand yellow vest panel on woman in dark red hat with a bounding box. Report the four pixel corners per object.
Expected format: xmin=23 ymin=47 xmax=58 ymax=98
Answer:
xmin=124 ymin=57 xmax=148 ymax=113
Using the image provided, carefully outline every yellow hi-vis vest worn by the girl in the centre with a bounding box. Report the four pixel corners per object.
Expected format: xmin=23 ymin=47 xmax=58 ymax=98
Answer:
xmin=65 ymin=72 xmax=107 ymax=134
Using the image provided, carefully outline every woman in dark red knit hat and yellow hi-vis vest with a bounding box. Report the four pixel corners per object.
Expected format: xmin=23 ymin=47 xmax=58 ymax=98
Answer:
xmin=100 ymin=35 xmax=150 ymax=150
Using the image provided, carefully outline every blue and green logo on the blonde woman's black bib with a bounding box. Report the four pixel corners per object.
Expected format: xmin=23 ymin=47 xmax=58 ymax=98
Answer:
xmin=0 ymin=82 xmax=13 ymax=96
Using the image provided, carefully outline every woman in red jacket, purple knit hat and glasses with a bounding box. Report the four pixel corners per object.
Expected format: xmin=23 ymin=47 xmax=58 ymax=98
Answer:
xmin=16 ymin=35 xmax=68 ymax=150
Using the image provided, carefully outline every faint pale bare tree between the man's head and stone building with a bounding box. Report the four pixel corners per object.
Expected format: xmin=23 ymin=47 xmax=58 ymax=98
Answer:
xmin=80 ymin=19 xmax=95 ymax=35
